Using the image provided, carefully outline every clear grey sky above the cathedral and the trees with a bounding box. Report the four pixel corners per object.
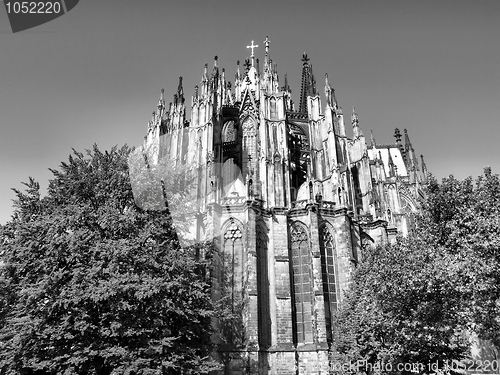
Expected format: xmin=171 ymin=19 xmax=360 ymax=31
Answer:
xmin=0 ymin=0 xmax=500 ymax=224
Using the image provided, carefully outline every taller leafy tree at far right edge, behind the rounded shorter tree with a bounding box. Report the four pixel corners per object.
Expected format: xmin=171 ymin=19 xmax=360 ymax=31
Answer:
xmin=422 ymin=168 xmax=500 ymax=347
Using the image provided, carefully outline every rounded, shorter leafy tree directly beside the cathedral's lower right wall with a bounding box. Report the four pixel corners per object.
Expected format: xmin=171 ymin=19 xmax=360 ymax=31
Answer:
xmin=334 ymin=237 xmax=469 ymax=373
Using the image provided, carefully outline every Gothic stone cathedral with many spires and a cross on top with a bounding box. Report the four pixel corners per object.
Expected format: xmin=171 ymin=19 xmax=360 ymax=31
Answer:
xmin=144 ymin=37 xmax=427 ymax=374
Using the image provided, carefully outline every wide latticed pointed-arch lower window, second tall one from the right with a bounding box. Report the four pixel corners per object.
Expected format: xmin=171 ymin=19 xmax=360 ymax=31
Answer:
xmin=290 ymin=223 xmax=313 ymax=343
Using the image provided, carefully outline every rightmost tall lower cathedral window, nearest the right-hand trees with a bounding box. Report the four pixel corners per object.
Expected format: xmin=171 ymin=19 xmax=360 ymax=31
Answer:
xmin=319 ymin=225 xmax=337 ymax=342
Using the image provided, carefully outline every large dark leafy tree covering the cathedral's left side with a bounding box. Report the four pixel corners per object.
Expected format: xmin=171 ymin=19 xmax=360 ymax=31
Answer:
xmin=0 ymin=146 xmax=219 ymax=374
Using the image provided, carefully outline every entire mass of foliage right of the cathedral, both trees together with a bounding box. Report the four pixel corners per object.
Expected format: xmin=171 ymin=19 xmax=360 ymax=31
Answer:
xmin=335 ymin=169 xmax=500 ymax=372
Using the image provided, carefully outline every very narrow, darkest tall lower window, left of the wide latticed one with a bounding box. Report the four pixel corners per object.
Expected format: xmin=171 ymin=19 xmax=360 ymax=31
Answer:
xmin=257 ymin=223 xmax=271 ymax=348
